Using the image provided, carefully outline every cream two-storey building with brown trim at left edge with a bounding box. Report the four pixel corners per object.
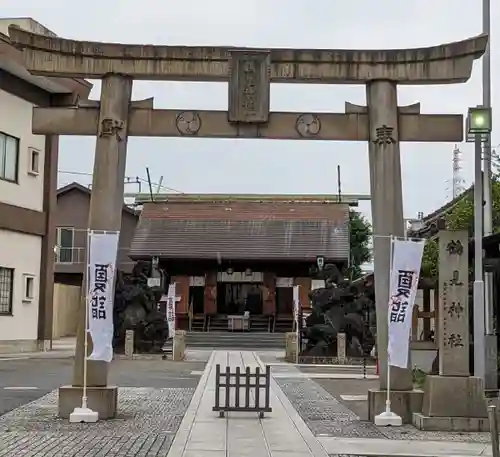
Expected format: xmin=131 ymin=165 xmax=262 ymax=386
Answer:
xmin=0 ymin=18 xmax=91 ymax=353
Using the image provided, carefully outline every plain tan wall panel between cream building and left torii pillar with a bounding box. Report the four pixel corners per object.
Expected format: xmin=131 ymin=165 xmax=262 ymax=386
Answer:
xmin=52 ymin=284 xmax=82 ymax=338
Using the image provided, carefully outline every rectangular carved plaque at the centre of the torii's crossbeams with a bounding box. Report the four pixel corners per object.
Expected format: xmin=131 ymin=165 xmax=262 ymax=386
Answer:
xmin=228 ymin=51 xmax=271 ymax=123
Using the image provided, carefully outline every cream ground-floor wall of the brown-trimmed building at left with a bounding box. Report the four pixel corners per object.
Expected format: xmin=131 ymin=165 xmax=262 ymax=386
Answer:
xmin=0 ymin=230 xmax=42 ymax=353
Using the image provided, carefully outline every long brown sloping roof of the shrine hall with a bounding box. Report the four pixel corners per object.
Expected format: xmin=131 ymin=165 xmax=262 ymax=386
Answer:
xmin=130 ymin=197 xmax=349 ymax=261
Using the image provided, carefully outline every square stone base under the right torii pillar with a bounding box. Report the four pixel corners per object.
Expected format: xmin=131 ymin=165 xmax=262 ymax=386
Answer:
xmin=368 ymin=389 xmax=424 ymax=424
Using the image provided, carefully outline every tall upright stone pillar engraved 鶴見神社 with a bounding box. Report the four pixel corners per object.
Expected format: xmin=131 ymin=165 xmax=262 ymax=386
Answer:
xmin=438 ymin=230 xmax=469 ymax=376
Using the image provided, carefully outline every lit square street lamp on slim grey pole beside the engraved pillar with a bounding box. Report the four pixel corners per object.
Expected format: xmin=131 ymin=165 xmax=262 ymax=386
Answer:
xmin=466 ymin=106 xmax=491 ymax=380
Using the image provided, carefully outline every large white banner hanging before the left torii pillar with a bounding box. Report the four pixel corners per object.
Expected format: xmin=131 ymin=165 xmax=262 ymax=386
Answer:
xmin=87 ymin=231 xmax=120 ymax=362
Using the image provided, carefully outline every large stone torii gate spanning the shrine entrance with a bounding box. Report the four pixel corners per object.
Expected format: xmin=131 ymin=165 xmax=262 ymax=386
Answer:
xmin=9 ymin=26 xmax=488 ymax=418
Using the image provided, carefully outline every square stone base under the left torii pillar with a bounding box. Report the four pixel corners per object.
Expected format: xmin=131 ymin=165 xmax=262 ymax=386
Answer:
xmin=58 ymin=386 xmax=118 ymax=420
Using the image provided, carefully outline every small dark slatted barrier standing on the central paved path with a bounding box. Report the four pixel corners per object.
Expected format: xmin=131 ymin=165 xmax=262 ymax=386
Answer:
xmin=212 ymin=365 xmax=273 ymax=418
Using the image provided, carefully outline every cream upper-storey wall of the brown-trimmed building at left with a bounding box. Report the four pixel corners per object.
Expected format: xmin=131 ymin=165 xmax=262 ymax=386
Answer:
xmin=0 ymin=90 xmax=45 ymax=211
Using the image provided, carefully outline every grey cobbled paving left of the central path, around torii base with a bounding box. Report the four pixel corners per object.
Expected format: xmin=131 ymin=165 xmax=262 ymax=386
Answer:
xmin=0 ymin=388 xmax=194 ymax=457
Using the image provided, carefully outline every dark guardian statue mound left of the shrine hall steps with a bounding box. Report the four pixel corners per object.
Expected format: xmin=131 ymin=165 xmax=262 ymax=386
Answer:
xmin=113 ymin=261 xmax=169 ymax=353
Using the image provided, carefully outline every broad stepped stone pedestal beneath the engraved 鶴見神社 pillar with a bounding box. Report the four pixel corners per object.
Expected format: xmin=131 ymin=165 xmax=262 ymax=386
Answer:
xmin=413 ymin=376 xmax=488 ymax=432
